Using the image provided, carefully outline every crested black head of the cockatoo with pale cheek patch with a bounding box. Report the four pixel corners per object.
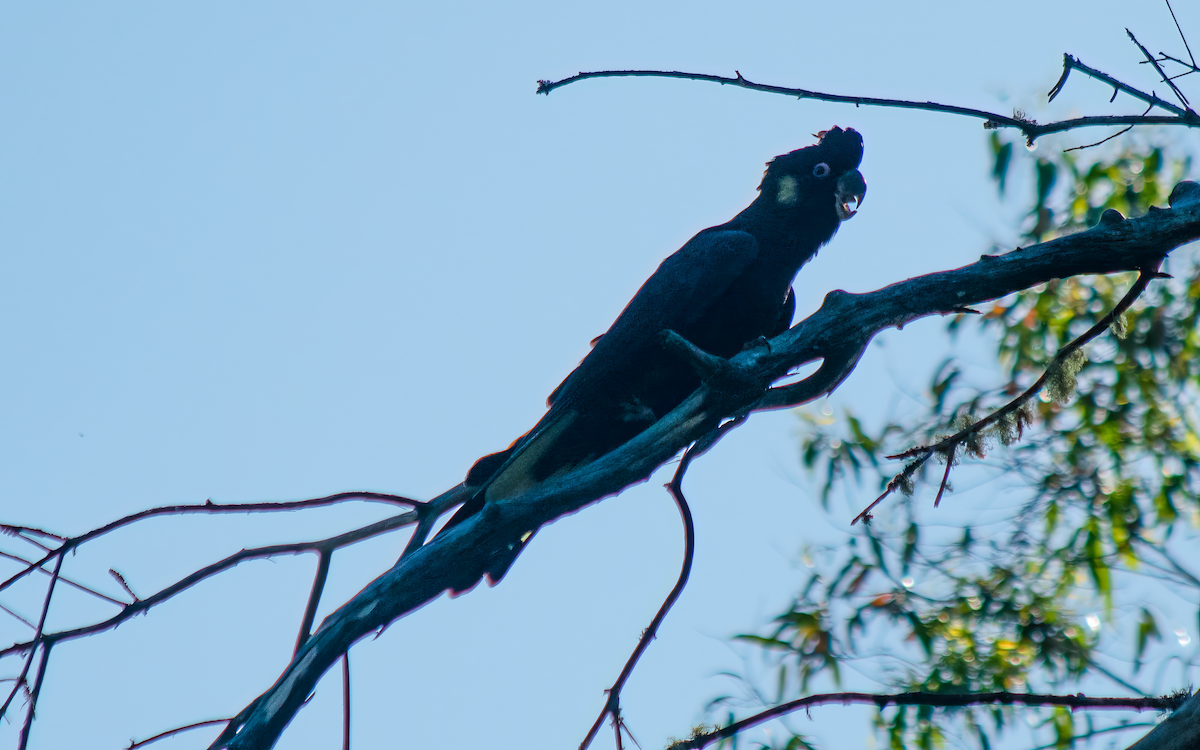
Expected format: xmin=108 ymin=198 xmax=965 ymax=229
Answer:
xmin=758 ymin=126 xmax=866 ymax=221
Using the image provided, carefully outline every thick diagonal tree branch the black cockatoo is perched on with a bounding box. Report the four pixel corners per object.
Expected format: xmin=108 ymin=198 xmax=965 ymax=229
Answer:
xmin=211 ymin=182 xmax=1200 ymax=750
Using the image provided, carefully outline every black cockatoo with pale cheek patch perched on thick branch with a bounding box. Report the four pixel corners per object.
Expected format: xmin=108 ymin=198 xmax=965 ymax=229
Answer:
xmin=448 ymin=127 xmax=866 ymax=583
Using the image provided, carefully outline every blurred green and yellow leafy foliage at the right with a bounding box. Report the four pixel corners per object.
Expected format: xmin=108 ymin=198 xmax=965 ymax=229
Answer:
xmin=715 ymin=134 xmax=1200 ymax=750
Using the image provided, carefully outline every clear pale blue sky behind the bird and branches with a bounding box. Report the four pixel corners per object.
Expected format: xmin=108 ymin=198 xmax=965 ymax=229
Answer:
xmin=0 ymin=1 xmax=1200 ymax=749
